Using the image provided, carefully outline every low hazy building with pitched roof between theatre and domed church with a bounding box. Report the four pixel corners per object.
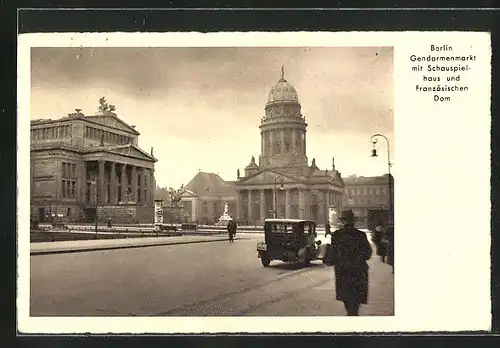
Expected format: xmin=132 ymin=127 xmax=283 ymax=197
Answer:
xmin=181 ymin=171 xmax=236 ymax=224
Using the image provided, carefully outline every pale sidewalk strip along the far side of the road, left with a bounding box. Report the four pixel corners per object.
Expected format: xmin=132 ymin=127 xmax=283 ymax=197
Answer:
xmin=30 ymin=235 xmax=247 ymax=255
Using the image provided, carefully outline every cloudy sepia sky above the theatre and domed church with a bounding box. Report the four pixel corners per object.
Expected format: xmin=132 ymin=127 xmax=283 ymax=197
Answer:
xmin=31 ymin=47 xmax=394 ymax=188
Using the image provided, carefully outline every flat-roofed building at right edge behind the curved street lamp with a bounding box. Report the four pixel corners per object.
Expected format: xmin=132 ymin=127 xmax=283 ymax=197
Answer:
xmin=344 ymin=175 xmax=394 ymax=228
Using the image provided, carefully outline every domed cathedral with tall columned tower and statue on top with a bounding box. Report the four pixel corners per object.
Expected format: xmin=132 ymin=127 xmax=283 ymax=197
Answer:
xmin=236 ymin=67 xmax=344 ymax=224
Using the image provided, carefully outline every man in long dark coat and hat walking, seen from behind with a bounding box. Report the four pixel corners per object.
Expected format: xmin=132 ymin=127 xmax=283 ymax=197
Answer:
xmin=328 ymin=210 xmax=372 ymax=316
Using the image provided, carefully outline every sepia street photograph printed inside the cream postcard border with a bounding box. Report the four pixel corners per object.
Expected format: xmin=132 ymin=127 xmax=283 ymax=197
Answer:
xmin=30 ymin=47 xmax=394 ymax=316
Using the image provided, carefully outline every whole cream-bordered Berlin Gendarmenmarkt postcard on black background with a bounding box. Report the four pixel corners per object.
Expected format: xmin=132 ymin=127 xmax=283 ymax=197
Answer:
xmin=17 ymin=32 xmax=491 ymax=334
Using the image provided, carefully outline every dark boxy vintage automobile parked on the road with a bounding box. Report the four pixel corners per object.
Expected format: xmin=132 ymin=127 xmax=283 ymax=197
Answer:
xmin=257 ymin=219 xmax=326 ymax=267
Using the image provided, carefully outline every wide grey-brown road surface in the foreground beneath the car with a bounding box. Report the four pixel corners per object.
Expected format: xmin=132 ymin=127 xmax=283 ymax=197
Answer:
xmin=30 ymin=234 xmax=394 ymax=316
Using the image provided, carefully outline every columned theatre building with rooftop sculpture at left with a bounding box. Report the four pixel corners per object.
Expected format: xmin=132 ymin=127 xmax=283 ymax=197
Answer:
xmin=30 ymin=99 xmax=157 ymax=226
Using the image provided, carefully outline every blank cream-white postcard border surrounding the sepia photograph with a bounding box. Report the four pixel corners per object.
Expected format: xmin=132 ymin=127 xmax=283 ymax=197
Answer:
xmin=17 ymin=32 xmax=491 ymax=334
